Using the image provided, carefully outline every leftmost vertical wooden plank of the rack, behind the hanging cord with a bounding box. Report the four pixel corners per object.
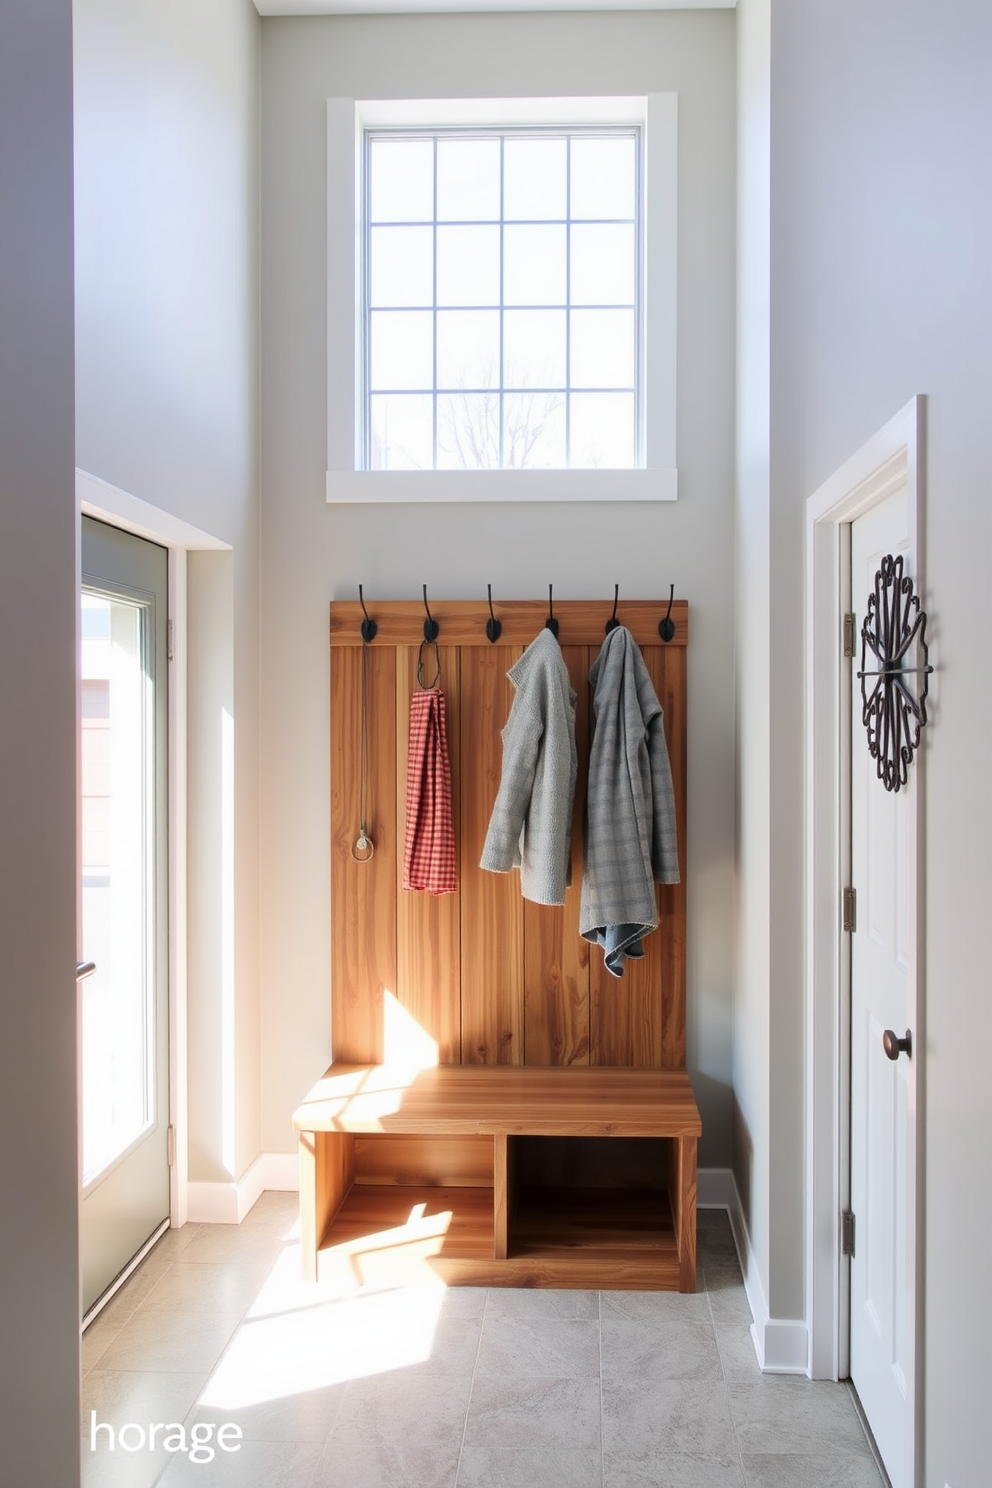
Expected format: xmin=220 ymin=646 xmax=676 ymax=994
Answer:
xmin=330 ymin=646 xmax=396 ymax=1064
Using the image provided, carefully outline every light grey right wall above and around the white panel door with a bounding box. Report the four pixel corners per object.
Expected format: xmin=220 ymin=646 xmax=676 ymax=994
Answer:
xmin=772 ymin=0 xmax=992 ymax=1488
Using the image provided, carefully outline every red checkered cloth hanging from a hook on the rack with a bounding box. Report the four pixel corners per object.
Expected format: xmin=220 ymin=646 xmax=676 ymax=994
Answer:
xmin=403 ymin=687 xmax=458 ymax=894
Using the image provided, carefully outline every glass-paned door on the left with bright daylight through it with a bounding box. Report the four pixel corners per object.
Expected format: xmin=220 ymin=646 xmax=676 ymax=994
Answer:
xmin=79 ymin=518 xmax=170 ymax=1314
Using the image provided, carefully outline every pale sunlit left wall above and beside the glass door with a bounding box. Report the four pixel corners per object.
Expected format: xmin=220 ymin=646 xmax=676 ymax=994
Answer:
xmin=74 ymin=0 xmax=260 ymax=1180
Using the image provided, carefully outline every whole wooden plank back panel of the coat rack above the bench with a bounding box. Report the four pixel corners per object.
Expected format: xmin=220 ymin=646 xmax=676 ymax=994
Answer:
xmin=330 ymin=601 xmax=689 ymax=1068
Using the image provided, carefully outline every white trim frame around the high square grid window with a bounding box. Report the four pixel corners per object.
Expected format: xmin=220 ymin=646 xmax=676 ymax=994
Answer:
xmin=327 ymin=94 xmax=678 ymax=504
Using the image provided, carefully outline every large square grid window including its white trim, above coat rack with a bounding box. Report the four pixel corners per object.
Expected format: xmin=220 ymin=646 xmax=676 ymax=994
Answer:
xmin=327 ymin=94 xmax=677 ymax=501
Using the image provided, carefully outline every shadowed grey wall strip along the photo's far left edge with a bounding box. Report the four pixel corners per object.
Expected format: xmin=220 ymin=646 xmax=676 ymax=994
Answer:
xmin=0 ymin=0 xmax=79 ymax=1488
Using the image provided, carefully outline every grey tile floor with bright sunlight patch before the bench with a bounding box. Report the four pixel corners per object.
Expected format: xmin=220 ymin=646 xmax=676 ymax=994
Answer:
xmin=82 ymin=1193 xmax=882 ymax=1488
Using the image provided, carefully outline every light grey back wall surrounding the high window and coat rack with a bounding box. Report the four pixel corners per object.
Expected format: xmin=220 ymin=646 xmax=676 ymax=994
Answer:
xmin=262 ymin=12 xmax=735 ymax=1165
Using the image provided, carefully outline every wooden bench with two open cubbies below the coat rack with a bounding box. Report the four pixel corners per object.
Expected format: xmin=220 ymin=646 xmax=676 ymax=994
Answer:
xmin=293 ymin=1064 xmax=702 ymax=1292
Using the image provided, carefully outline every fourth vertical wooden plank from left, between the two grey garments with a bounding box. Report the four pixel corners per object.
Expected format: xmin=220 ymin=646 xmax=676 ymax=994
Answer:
xmin=524 ymin=646 xmax=593 ymax=1065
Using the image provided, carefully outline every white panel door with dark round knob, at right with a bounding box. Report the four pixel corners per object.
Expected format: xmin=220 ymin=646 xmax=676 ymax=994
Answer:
xmin=851 ymin=488 xmax=919 ymax=1488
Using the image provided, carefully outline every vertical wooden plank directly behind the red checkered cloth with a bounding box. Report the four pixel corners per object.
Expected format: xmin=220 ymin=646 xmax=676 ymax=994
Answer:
xmin=396 ymin=646 xmax=463 ymax=1064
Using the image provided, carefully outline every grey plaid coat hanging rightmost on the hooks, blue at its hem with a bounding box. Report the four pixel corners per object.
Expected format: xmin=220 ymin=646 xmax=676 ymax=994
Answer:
xmin=579 ymin=625 xmax=678 ymax=976
